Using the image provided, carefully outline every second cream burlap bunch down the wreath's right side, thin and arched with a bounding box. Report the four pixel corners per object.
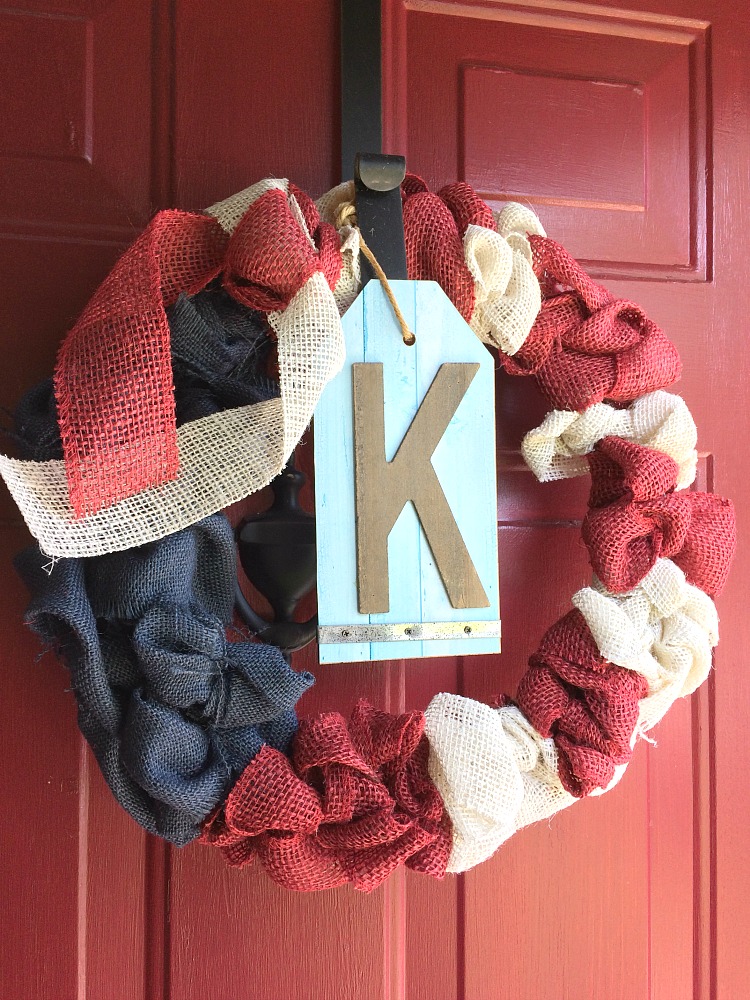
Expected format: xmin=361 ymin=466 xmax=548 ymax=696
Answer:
xmin=521 ymin=390 xmax=698 ymax=490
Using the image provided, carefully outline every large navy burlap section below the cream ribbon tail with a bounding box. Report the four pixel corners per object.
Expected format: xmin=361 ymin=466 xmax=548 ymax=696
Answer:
xmin=18 ymin=515 xmax=313 ymax=844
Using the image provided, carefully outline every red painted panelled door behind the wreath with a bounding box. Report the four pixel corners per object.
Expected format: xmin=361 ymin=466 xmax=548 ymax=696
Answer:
xmin=0 ymin=0 xmax=750 ymax=1000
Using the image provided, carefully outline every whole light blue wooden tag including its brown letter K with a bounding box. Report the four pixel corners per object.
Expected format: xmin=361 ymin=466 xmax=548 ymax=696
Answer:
xmin=315 ymin=281 xmax=500 ymax=663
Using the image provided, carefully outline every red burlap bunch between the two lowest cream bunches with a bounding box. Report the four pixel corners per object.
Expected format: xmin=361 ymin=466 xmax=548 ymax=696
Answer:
xmin=516 ymin=610 xmax=648 ymax=797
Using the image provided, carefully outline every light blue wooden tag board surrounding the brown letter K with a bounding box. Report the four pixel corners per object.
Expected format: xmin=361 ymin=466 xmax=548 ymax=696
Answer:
xmin=315 ymin=281 xmax=500 ymax=663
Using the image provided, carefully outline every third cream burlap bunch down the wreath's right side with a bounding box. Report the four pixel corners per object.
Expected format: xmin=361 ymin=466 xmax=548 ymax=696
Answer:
xmin=573 ymin=559 xmax=719 ymax=732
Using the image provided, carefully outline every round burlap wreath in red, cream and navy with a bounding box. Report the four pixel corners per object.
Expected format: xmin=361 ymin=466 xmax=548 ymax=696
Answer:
xmin=0 ymin=175 xmax=735 ymax=891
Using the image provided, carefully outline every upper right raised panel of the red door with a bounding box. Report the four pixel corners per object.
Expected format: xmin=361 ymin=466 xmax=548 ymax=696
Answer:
xmin=388 ymin=0 xmax=709 ymax=281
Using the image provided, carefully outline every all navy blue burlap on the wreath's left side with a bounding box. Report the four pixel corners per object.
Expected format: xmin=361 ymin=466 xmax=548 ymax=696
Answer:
xmin=13 ymin=287 xmax=313 ymax=844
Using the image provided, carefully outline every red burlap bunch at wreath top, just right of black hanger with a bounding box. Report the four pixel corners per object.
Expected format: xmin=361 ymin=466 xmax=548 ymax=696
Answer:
xmin=402 ymin=174 xmax=495 ymax=323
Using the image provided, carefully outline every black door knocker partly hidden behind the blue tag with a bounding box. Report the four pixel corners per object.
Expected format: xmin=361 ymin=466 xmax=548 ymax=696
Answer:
xmin=235 ymin=458 xmax=318 ymax=659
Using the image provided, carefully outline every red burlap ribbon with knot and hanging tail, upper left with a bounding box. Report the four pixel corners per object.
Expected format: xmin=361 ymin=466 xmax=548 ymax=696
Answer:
xmin=55 ymin=186 xmax=342 ymax=517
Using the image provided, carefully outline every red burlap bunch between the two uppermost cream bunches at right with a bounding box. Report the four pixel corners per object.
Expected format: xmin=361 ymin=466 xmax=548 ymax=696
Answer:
xmin=502 ymin=235 xmax=681 ymax=410
